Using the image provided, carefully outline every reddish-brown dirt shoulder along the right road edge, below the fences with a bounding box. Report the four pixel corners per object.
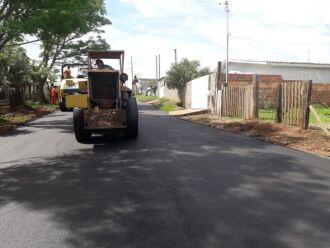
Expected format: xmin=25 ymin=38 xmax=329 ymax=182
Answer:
xmin=180 ymin=114 xmax=330 ymax=157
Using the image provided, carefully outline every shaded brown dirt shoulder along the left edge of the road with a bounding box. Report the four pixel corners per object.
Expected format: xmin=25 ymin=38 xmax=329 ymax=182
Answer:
xmin=0 ymin=105 xmax=55 ymax=135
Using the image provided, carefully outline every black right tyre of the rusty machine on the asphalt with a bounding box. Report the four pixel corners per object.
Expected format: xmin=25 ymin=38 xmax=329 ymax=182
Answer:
xmin=125 ymin=97 xmax=139 ymax=139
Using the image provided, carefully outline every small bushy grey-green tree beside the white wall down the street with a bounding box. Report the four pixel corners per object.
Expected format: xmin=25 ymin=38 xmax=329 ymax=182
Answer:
xmin=165 ymin=58 xmax=210 ymax=106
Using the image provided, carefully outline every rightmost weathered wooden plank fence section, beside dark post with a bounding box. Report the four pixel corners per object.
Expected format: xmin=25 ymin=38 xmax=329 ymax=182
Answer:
xmin=276 ymin=81 xmax=312 ymax=129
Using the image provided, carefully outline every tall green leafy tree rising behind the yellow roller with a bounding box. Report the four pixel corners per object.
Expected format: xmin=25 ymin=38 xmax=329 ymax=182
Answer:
xmin=26 ymin=0 xmax=111 ymax=102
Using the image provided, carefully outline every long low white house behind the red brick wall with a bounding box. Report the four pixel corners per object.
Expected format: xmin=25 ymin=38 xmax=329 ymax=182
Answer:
xmin=227 ymin=59 xmax=330 ymax=83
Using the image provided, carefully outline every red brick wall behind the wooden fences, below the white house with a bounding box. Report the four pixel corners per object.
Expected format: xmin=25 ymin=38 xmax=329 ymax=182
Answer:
xmin=220 ymin=73 xmax=330 ymax=106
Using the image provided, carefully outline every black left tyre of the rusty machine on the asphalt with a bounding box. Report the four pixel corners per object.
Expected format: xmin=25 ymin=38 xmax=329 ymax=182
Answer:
xmin=73 ymin=108 xmax=92 ymax=143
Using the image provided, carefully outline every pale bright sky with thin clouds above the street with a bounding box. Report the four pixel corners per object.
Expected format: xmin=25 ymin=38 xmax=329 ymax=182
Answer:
xmin=27 ymin=0 xmax=330 ymax=81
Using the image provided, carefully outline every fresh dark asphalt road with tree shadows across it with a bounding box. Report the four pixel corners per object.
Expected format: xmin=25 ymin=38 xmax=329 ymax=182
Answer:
xmin=0 ymin=101 xmax=330 ymax=248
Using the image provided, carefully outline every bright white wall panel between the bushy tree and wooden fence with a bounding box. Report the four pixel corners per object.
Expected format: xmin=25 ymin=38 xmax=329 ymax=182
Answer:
xmin=191 ymin=75 xmax=209 ymax=109
